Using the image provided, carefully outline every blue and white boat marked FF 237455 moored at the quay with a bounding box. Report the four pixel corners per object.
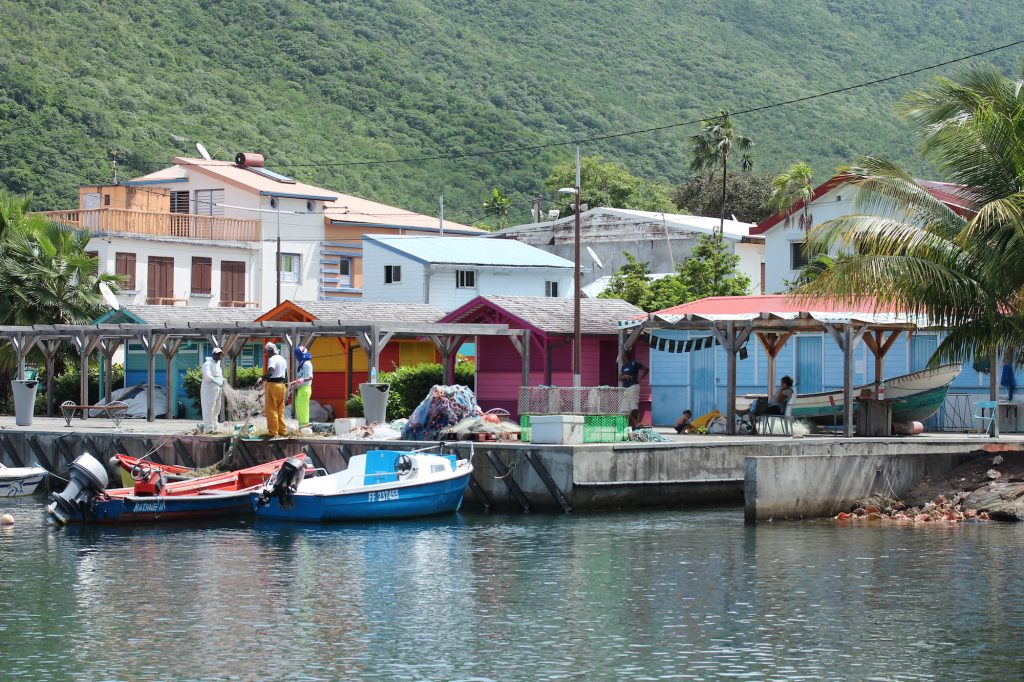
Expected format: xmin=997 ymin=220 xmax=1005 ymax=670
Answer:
xmin=260 ymin=450 xmax=473 ymax=521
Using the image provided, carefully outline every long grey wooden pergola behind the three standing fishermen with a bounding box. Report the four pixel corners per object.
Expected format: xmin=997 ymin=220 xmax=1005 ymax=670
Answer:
xmin=0 ymin=319 xmax=529 ymax=421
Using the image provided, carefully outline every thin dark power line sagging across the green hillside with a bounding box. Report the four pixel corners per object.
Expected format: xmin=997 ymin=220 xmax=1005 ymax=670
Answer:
xmin=99 ymin=39 xmax=1024 ymax=173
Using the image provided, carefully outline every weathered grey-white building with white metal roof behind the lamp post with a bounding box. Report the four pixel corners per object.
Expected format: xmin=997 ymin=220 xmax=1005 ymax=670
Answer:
xmin=493 ymin=208 xmax=764 ymax=294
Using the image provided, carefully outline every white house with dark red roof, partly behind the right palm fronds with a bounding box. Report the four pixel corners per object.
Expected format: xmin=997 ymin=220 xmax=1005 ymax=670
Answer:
xmin=751 ymin=175 xmax=965 ymax=294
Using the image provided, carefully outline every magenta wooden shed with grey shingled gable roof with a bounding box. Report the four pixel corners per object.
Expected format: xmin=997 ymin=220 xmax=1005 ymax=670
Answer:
xmin=440 ymin=296 xmax=650 ymax=423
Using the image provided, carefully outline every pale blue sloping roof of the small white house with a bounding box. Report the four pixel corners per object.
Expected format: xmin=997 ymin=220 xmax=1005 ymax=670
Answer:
xmin=362 ymin=235 xmax=573 ymax=268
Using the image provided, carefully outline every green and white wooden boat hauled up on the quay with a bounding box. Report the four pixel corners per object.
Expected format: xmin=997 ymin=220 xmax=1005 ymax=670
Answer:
xmin=793 ymin=363 xmax=963 ymax=425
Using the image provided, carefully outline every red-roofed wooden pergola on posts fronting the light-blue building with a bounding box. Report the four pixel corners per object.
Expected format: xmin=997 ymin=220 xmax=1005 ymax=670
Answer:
xmin=621 ymin=296 xmax=933 ymax=437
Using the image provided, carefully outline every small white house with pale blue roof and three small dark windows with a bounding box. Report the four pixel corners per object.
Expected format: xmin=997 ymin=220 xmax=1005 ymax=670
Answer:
xmin=362 ymin=235 xmax=573 ymax=312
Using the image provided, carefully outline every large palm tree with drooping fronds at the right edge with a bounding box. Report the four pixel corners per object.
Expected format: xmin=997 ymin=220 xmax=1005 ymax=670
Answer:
xmin=799 ymin=65 xmax=1024 ymax=363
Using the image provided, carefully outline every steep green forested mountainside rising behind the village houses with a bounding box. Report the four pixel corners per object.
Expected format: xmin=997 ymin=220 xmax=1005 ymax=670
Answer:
xmin=0 ymin=0 xmax=1022 ymax=222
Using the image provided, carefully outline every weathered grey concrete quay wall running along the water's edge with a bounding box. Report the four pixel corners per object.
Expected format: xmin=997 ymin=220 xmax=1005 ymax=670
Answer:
xmin=0 ymin=417 xmax=1024 ymax=522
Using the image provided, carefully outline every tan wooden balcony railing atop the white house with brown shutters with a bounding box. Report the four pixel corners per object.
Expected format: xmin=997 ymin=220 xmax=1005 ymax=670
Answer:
xmin=40 ymin=208 xmax=260 ymax=242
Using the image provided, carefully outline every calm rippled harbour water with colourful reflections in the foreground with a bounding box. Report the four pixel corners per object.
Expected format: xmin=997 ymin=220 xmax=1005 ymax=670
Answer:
xmin=0 ymin=499 xmax=1024 ymax=680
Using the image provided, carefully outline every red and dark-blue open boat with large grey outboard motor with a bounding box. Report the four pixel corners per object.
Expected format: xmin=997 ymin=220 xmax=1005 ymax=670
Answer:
xmin=47 ymin=454 xmax=305 ymax=524
